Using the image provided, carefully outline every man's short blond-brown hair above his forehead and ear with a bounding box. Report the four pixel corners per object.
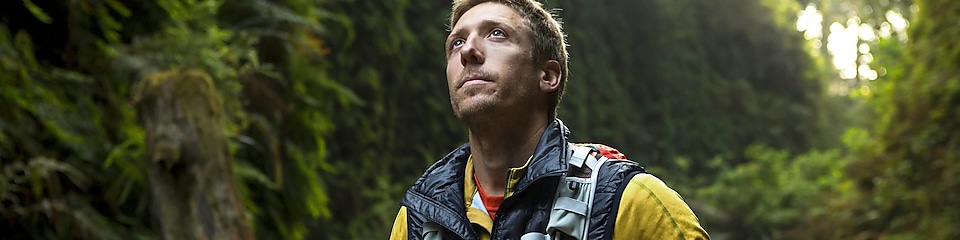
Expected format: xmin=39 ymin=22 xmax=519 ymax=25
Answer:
xmin=450 ymin=0 xmax=570 ymax=117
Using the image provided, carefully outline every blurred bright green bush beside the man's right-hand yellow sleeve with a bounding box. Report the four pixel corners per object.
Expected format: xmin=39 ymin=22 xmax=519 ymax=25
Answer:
xmin=687 ymin=145 xmax=853 ymax=239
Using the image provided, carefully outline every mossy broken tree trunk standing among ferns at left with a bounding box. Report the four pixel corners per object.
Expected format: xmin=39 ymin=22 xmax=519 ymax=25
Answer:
xmin=133 ymin=69 xmax=254 ymax=240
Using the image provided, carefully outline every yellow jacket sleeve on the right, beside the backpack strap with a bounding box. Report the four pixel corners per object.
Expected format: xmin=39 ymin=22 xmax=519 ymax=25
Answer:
xmin=613 ymin=174 xmax=710 ymax=239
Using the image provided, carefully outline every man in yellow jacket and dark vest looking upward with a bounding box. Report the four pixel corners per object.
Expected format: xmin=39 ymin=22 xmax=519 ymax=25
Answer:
xmin=391 ymin=0 xmax=709 ymax=239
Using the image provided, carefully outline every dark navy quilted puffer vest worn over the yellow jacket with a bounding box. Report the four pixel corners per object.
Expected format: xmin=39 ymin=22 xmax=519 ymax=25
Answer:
xmin=400 ymin=119 xmax=643 ymax=240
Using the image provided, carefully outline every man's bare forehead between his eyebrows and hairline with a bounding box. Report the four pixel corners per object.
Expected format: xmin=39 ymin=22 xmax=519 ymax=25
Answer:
xmin=453 ymin=2 xmax=522 ymax=31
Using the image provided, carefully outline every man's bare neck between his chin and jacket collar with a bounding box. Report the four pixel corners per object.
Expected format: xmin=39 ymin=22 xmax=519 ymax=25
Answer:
xmin=470 ymin=117 xmax=550 ymax=196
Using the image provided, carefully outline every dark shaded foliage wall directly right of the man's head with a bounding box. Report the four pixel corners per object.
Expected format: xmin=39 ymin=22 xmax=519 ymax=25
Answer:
xmin=556 ymin=0 xmax=831 ymax=175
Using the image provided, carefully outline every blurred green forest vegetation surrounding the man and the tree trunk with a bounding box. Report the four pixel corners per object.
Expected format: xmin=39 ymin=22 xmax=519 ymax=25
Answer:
xmin=0 ymin=0 xmax=960 ymax=239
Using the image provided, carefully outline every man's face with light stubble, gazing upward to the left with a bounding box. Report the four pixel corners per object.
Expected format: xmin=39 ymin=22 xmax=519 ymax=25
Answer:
xmin=446 ymin=2 xmax=542 ymax=124
